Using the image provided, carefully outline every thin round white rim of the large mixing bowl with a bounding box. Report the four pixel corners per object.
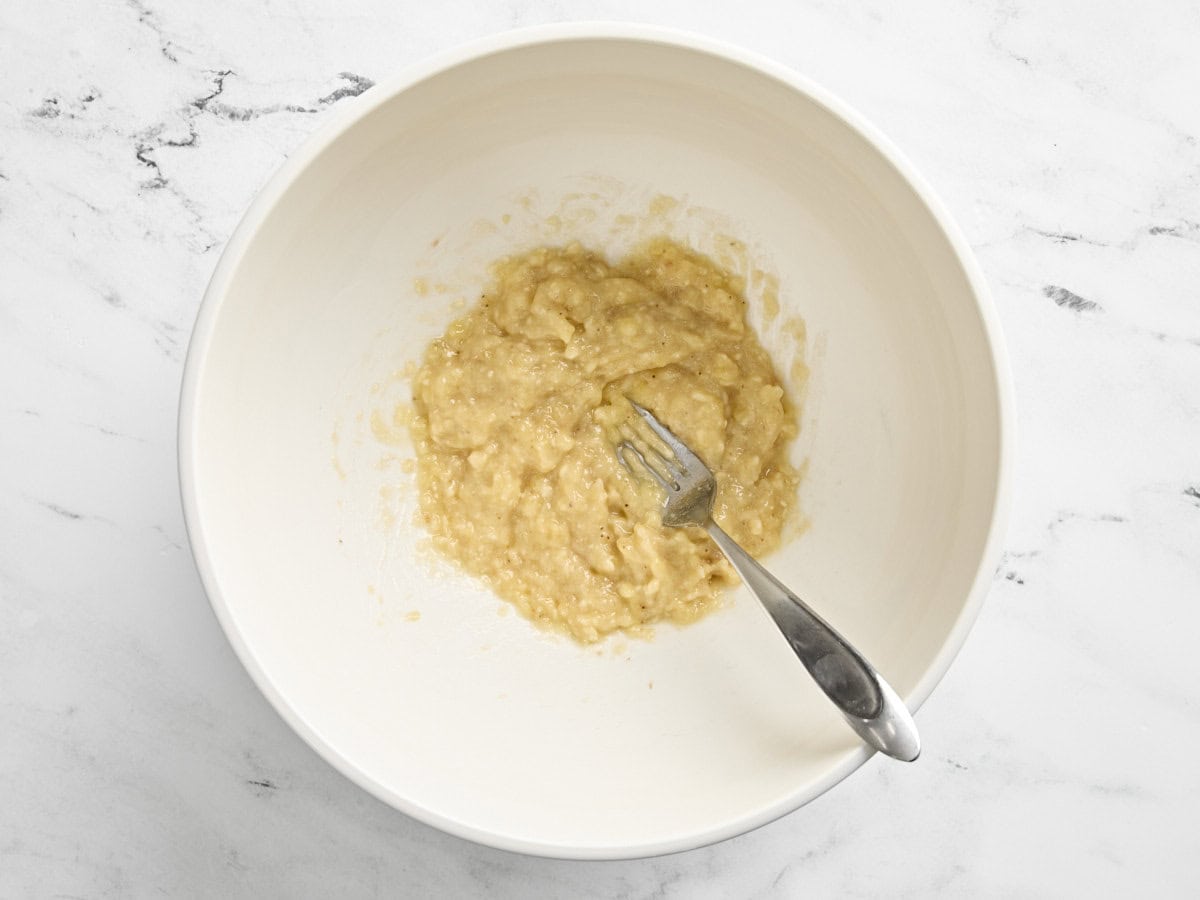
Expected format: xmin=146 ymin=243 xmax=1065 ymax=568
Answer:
xmin=176 ymin=22 xmax=1015 ymax=859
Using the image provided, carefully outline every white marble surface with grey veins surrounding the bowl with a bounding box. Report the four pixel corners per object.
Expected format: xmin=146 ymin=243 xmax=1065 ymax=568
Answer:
xmin=0 ymin=0 xmax=1200 ymax=898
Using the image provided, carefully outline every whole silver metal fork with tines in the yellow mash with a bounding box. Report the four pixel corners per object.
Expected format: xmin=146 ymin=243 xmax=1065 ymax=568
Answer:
xmin=616 ymin=401 xmax=920 ymax=762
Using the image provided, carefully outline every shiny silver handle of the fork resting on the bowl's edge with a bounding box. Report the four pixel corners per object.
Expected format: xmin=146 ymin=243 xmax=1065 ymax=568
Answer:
xmin=706 ymin=520 xmax=920 ymax=762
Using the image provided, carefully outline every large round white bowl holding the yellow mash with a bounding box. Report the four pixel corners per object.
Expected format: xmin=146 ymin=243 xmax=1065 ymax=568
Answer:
xmin=180 ymin=25 xmax=1013 ymax=858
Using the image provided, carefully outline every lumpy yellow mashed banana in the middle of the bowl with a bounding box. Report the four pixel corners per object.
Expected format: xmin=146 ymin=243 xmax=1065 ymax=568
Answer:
xmin=412 ymin=240 xmax=797 ymax=643
